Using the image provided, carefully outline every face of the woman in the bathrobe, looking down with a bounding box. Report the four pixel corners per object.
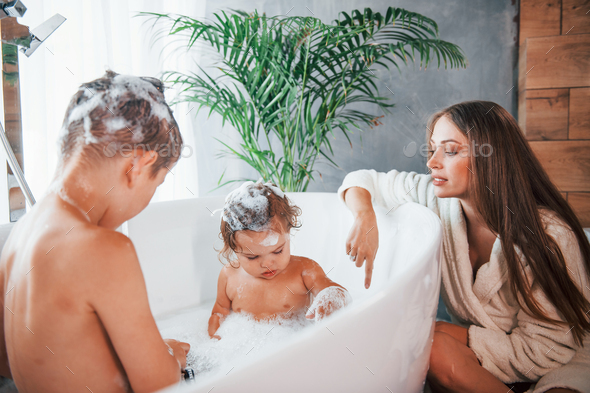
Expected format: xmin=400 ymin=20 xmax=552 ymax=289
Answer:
xmin=426 ymin=116 xmax=471 ymax=199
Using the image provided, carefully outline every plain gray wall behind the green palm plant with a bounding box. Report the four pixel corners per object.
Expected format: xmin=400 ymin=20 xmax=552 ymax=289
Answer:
xmin=194 ymin=0 xmax=518 ymax=196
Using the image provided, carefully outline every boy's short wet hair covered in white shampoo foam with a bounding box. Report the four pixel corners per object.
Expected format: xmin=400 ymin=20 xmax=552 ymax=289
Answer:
xmin=60 ymin=71 xmax=183 ymax=176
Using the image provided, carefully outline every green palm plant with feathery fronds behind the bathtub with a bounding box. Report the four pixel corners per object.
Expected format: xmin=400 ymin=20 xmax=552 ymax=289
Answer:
xmin=142 ymin=7 xmax=467 ymax=191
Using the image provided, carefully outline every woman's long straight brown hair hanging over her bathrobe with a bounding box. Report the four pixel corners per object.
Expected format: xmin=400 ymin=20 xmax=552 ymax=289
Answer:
xmin=427 ymin=101 xmax=590 ymax=345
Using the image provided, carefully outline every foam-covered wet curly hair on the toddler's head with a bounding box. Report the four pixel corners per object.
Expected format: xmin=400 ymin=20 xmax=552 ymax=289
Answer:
xmin=220 ymin=180 xmax=301 ymax=262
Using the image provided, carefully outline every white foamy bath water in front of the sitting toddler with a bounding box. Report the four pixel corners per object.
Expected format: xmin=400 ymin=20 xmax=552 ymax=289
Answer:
xmin=158 ymin=307 xmax=314 ymax=381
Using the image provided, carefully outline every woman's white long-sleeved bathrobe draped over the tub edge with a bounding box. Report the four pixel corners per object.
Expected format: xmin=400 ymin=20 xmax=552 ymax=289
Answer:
xmin=338 ymin=170 xmax=590 ymax=393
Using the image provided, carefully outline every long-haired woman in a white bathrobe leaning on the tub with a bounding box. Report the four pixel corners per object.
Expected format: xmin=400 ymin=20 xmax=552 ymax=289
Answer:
xmin=338 ymin=101 xmax=590 ymax=393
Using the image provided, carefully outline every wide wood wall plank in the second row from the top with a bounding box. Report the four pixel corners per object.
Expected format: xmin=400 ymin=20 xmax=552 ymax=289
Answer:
xmin=518 ymin=34 xmax=590 ymax=91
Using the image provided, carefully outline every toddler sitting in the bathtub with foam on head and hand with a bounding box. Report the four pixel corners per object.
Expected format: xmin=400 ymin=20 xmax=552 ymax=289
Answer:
xmin=208 ymin=181 xmax=351 ymax=339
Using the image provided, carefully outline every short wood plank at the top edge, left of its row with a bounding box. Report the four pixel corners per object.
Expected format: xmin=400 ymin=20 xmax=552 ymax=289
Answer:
xmin=518 ymin=0 xmax=561 ymax=45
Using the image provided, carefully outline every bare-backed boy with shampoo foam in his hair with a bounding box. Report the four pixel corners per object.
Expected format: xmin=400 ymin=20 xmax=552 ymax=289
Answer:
xmin=0 ymin=71 xmax=190 ymax=393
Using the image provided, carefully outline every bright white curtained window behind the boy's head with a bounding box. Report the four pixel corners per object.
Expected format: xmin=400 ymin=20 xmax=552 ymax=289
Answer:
xmin=0 ymin=0 xmax=205 ymax=222
